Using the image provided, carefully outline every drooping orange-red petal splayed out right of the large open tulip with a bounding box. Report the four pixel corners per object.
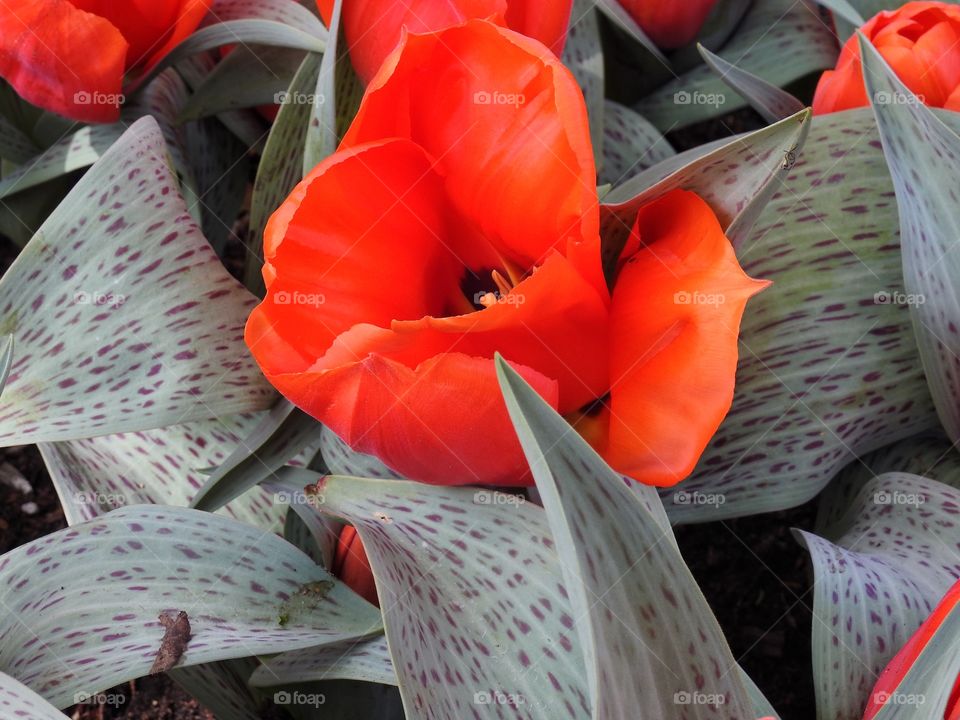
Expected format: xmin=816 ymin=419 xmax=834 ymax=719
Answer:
xmin=603 ymin=190 xmax=766 ymax=486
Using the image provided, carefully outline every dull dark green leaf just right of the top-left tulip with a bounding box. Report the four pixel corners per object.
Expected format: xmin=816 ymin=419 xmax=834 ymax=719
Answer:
xmin=180 ymin=45 xmax=304 ymax=121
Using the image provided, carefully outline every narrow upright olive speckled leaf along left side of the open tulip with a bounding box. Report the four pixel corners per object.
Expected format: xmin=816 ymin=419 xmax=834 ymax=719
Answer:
xmin=244 ymin=53 xmax=320 ymax=295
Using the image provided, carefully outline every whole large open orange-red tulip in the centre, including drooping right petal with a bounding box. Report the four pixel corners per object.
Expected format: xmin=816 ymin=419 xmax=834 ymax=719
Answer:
xmin=246 ymin=20 xmax=764 ymax=486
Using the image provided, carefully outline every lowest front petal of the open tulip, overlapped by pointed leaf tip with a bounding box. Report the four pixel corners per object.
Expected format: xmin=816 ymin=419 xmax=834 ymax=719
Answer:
xmin=270 ymin=353 xmax=558 ymax=486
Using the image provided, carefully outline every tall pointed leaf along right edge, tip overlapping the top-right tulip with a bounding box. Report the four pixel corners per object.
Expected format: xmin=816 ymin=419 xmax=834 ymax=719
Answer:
xmin=860 ymin=36 xmax=960 ymax=442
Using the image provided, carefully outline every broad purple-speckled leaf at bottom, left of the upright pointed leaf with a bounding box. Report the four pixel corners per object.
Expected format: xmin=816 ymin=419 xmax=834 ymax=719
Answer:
xmin=304 ymin=471 xmax=590 ymax=720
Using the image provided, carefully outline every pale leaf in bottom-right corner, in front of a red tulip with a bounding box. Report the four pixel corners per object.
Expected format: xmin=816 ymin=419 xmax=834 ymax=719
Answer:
xmin=873 ymin=592 xmax=960 ymax=720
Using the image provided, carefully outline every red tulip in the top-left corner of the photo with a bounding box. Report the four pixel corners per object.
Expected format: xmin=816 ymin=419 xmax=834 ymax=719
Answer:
xmin=0 ymin=0 xmax=213 ymax=122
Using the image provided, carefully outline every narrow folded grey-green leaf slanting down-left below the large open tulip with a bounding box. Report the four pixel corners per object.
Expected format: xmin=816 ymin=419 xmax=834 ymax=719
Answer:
xmin=192 ymin=400 xmax=322 ymax=512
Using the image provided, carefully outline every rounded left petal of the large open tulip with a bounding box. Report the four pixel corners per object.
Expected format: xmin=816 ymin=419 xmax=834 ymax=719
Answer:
xmin=246 ymin=140 xmax=462 ymax=380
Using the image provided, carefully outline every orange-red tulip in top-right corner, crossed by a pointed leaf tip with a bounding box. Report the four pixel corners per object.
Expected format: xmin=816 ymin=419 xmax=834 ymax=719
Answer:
xmin=813 ymin=2 xmax=960 ymax=115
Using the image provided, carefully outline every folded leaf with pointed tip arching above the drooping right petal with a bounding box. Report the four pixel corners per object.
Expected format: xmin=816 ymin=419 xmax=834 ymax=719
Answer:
xmin=602 ymin=111 xmax=811 ymax=248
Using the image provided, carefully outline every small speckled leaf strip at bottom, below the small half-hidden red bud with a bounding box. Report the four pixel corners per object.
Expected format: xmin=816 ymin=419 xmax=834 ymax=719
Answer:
xmin=250 ymin=635 xmax=397 ymax=687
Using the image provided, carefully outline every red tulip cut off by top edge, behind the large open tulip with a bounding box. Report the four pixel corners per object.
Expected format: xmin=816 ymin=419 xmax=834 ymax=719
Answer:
xmin=317 ymin=0 xmax=573 ymax=83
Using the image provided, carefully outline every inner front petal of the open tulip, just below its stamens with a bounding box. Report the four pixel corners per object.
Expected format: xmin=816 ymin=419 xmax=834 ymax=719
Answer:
xmin=315 ymin=254 xmax=609 ymax=413
